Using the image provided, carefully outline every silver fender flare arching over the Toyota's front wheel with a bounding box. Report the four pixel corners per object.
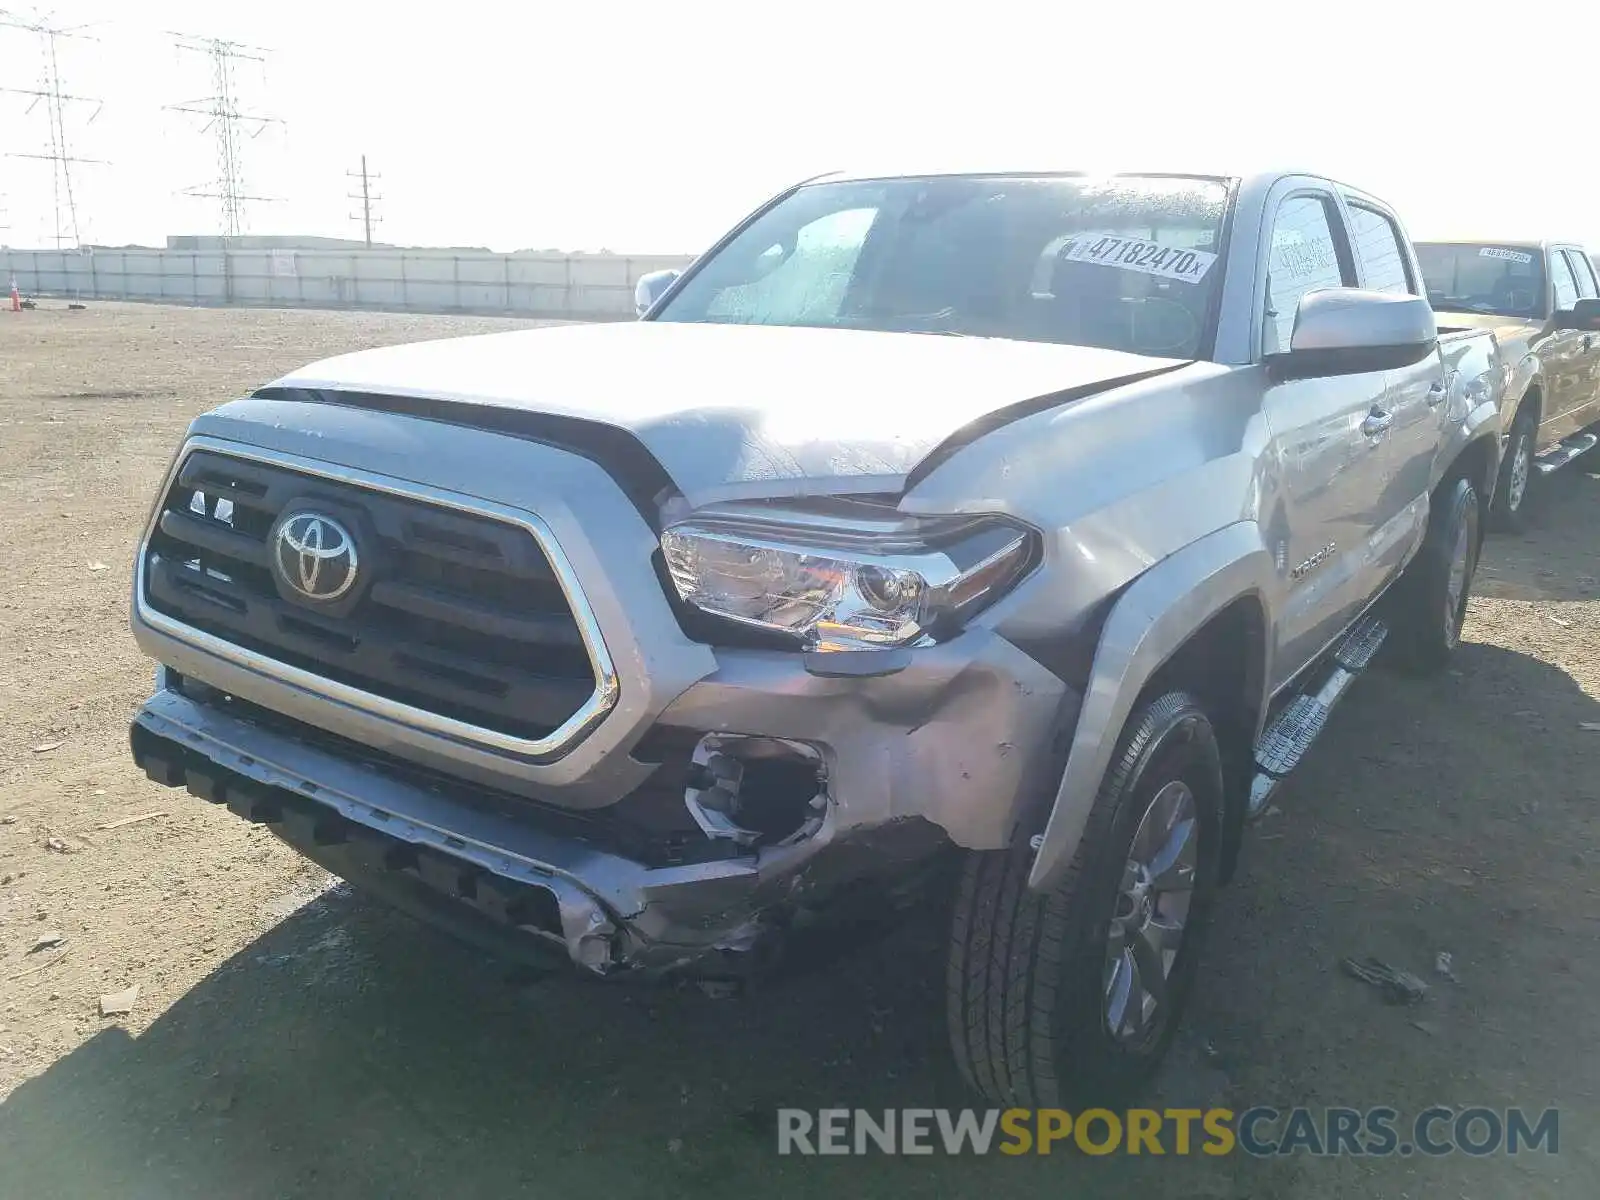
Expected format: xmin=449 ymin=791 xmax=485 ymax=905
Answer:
xmin=1027 ymin=522 xmax=1278 ymax=891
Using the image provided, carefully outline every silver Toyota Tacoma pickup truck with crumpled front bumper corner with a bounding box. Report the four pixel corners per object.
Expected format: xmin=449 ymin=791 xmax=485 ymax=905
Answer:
xmin=131 ymin=173 xmax=1504 ymax=1104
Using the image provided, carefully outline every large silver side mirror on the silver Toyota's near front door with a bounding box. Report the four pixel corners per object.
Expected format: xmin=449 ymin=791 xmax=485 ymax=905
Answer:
xmin=1267 ymin=288 xmax=1438 ymax=379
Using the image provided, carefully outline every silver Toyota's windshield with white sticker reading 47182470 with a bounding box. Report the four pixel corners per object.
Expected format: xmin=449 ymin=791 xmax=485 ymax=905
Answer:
xmin=654 ymin=176 xmax=1227 ymax=358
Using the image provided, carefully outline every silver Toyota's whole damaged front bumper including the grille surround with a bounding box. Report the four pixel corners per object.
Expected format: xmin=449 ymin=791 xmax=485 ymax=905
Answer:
xmin=131 ymin=419 xmax=1080 ymax=974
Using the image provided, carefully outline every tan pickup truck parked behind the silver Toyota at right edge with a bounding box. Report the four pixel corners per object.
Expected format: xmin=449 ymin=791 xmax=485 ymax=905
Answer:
xmin=1416 ymin=242 xmax=1600 ymax=530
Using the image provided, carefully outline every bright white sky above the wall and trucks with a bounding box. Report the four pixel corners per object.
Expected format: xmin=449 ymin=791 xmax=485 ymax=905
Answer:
xmin=0 ymin=0 xmax=1600 ymax=253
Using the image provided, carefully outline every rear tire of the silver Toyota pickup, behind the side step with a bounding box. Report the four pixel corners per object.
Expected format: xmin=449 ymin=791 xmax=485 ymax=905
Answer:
xmin=1390 ymin=478 xmax=1483 ymax=675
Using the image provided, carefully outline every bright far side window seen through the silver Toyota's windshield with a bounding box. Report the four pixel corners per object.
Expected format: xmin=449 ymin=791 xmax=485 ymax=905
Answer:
xmin=706 ymin=208 xmax=878 ymax=323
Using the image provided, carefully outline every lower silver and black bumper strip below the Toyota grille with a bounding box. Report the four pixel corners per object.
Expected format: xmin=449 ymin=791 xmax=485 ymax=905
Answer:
xmin=130 ymin=672 xmax=944 ymax=974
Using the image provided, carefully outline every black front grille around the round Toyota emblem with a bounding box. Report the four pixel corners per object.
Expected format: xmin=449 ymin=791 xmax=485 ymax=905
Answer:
xmin=144 ymin=450 xmax=597 ymax=739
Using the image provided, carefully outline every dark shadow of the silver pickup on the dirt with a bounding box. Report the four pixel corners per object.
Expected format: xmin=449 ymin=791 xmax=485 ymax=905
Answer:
xmin=0 ymin=611 xmax=1600 ymax=1200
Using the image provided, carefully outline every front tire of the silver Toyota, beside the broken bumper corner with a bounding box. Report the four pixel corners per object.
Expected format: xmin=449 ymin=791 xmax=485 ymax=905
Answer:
xmin=946 ymin=691 xmax=1222 ymax=1107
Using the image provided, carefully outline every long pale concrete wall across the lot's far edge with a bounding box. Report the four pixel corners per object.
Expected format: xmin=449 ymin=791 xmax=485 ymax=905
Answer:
xmin=0 ymin=248 xmax=690 ymax=320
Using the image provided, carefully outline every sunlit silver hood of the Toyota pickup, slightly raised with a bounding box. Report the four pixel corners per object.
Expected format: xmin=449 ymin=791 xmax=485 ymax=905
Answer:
xmin=259 ymin=322 xmax=1187 ymax=506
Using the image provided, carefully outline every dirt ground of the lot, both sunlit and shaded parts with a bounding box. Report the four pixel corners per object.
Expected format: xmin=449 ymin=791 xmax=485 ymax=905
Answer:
xmin=0 ymin=306 xmax=1600 ymax=1200
